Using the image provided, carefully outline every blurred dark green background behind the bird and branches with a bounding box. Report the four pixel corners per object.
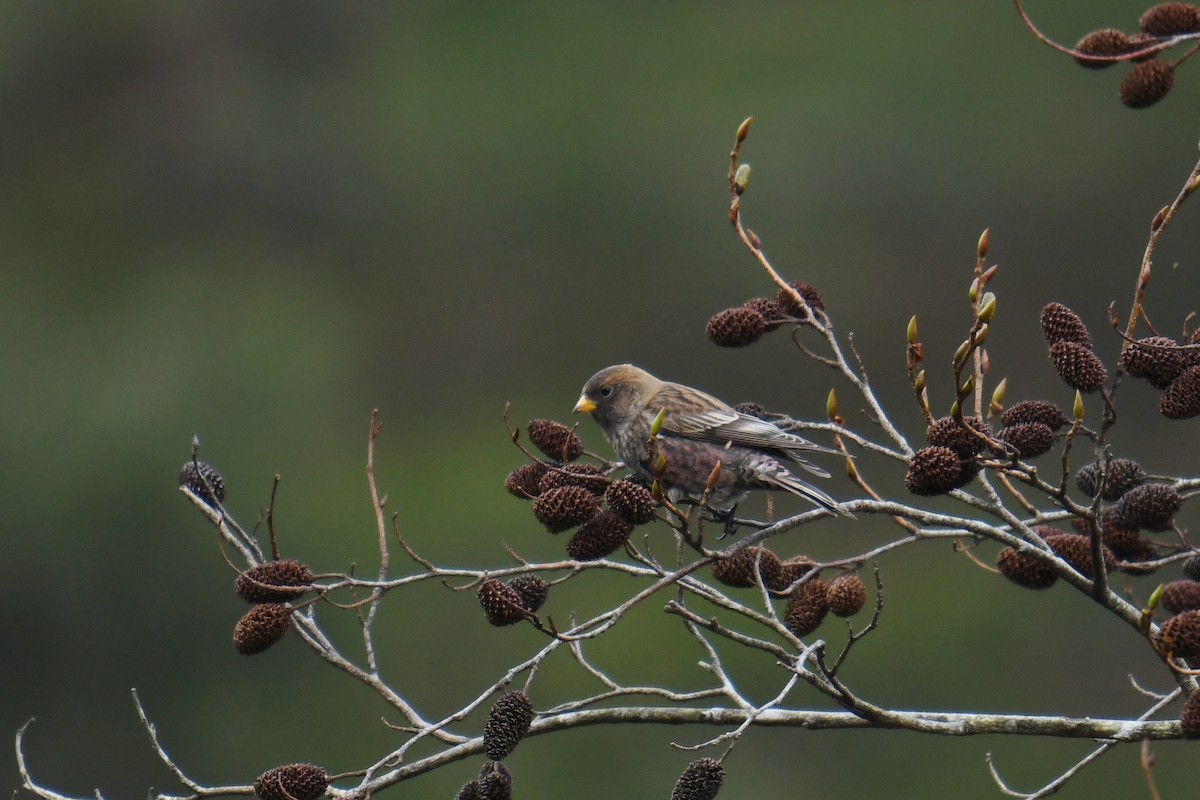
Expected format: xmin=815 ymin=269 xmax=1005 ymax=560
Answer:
xmin=0 ymin=0 xmax=1200 ymax=798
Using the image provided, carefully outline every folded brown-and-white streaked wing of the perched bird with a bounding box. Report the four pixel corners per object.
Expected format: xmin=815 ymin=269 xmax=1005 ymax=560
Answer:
xmin=647 ymin=384 xmax=838 ymax=477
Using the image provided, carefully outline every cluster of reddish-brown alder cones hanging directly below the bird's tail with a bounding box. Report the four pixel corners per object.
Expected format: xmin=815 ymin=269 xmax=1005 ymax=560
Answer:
xmin=713 ymin=545 xmax=866 ymax=637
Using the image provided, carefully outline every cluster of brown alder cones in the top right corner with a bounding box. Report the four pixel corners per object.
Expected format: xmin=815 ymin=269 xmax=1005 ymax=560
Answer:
xmin=1074 ymin=2 xmax=1200 ymax=108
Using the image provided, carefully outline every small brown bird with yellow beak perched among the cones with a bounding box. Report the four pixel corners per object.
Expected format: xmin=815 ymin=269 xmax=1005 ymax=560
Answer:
xmin=575 ymin=363 xmax=853 ymax=521
